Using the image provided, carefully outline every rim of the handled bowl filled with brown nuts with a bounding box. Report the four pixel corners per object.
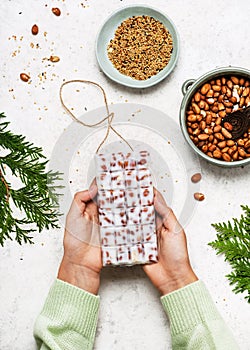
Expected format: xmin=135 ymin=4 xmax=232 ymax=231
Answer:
xmin=179 ymin=66 xmax=250 ymax=168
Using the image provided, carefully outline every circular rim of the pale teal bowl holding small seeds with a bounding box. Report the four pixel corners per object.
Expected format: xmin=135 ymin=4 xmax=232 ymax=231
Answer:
xmin=95 ymin=4 xmax=180 ymax=89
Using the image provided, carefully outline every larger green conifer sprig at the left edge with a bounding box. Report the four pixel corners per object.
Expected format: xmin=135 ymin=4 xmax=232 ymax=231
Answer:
xmin=0 ymin=113 xmax=62 ymax=246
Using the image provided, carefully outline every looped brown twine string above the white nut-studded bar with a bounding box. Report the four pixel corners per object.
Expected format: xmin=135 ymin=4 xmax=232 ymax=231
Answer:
xmin=59 ymin=79 xmax=133 ymax=153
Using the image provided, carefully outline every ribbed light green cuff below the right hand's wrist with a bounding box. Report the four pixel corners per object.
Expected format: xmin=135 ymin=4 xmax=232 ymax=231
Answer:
xmin=161 ymin=281 xmax=221 ymax=334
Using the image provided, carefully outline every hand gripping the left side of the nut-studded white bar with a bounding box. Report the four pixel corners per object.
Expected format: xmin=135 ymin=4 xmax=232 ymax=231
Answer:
xmin=58 ymin=183 xmax=102 ymax=294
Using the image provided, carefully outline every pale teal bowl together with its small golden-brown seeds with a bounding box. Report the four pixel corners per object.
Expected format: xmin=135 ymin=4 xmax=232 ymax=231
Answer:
xmin=96 ymin=5 xmax=179 ymax=88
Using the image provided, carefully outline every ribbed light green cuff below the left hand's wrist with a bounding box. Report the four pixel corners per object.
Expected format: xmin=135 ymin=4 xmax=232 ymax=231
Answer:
xmin=41 ymin=279 xmax=100 ymax=341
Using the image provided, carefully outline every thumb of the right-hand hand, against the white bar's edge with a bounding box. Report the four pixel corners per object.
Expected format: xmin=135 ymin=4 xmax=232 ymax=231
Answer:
xmin=154 ymin=188 xmax=182 ymax=233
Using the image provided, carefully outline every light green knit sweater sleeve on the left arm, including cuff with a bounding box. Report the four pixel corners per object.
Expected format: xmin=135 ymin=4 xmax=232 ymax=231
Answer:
xmin=34 ymin=279 xmax=100 ymax=350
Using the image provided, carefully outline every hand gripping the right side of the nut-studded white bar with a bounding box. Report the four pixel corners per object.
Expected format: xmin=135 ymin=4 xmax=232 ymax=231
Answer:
xmin=143 ymin=190 xmax=198 ymax=295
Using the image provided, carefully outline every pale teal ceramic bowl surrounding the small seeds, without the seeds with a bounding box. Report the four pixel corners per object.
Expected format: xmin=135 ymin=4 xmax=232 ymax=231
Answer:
xmin=96 ymin=5 xmax=179 ymax=89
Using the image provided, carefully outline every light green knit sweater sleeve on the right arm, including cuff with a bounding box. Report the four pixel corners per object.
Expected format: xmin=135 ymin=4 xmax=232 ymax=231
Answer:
xmin=161 ymin=281 xmax=239 ymax=350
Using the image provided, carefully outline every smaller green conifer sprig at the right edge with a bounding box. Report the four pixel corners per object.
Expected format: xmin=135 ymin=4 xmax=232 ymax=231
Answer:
xmin=209 ymin=205 xmax=250 ymax=303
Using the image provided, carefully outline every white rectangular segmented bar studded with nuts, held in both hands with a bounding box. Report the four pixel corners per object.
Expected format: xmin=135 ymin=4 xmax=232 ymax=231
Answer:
xmin=96 ymin=151 xmax=158 ymax=266
